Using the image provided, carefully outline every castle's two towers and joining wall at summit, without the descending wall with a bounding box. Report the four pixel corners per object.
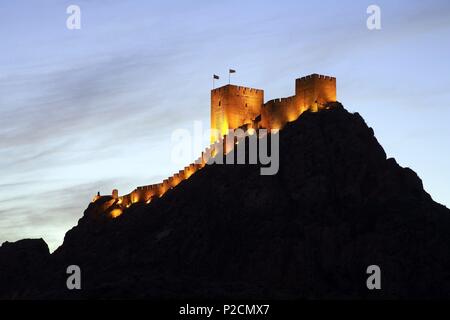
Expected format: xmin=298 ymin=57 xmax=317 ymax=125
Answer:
xmin=211 ymin=74 xmax=336 ymax=142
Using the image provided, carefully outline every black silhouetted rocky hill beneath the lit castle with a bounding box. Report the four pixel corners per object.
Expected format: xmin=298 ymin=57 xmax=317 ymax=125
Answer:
xmin=0 ymin=103 xmax=450 ymax=299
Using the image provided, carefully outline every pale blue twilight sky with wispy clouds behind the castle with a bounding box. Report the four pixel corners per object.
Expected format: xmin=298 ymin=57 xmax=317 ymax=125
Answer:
xmin=0 ymin=0 xmax=450 ymax=250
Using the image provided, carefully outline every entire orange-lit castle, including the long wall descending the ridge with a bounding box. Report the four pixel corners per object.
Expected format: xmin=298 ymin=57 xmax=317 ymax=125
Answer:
xmin=93 ymin=74 xmax=336 ymax=218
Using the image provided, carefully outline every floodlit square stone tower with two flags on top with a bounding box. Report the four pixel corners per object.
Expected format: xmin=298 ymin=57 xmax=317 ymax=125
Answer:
xmin=211 ymin=84 xmax=264 ymax=143
